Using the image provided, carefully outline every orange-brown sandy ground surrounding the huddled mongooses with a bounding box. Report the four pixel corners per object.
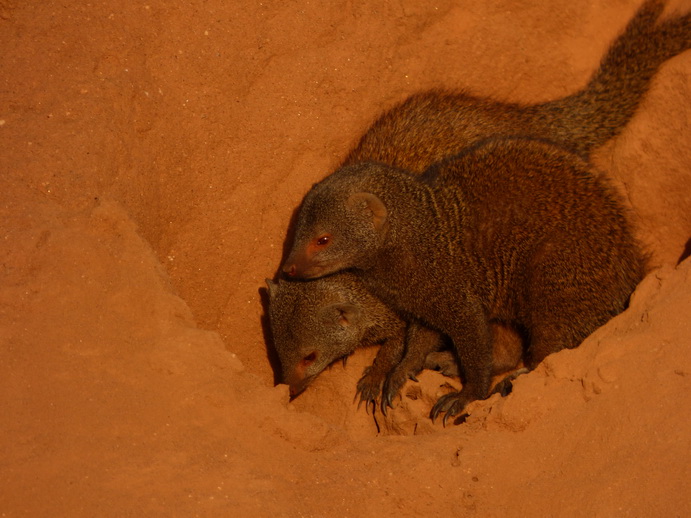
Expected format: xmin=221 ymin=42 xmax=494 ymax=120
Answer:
xmin=0 ymin=0 xmax=691 ymax=517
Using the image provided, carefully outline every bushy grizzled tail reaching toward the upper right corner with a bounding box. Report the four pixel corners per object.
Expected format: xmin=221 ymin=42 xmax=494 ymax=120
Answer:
xmin=532 ymin=0 xmax=691 ymax=156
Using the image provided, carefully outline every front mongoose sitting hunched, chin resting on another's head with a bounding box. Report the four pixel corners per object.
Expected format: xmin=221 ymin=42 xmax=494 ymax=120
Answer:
xmin=283 ymin=138 xmax=645 ymax=422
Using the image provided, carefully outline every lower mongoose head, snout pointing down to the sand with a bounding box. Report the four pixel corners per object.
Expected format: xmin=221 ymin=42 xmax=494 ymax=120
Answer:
xmin=266 ymin=275 xmax=367 ymax=397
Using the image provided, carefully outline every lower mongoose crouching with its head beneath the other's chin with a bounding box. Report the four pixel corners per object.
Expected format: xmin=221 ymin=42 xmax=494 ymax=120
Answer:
xmin=266 ymin=272 xmax=522 ymax=413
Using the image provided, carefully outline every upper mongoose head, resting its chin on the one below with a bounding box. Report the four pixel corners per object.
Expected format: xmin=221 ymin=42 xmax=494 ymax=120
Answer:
xmin=283 ymin=168 xmax=389 ymax=279
